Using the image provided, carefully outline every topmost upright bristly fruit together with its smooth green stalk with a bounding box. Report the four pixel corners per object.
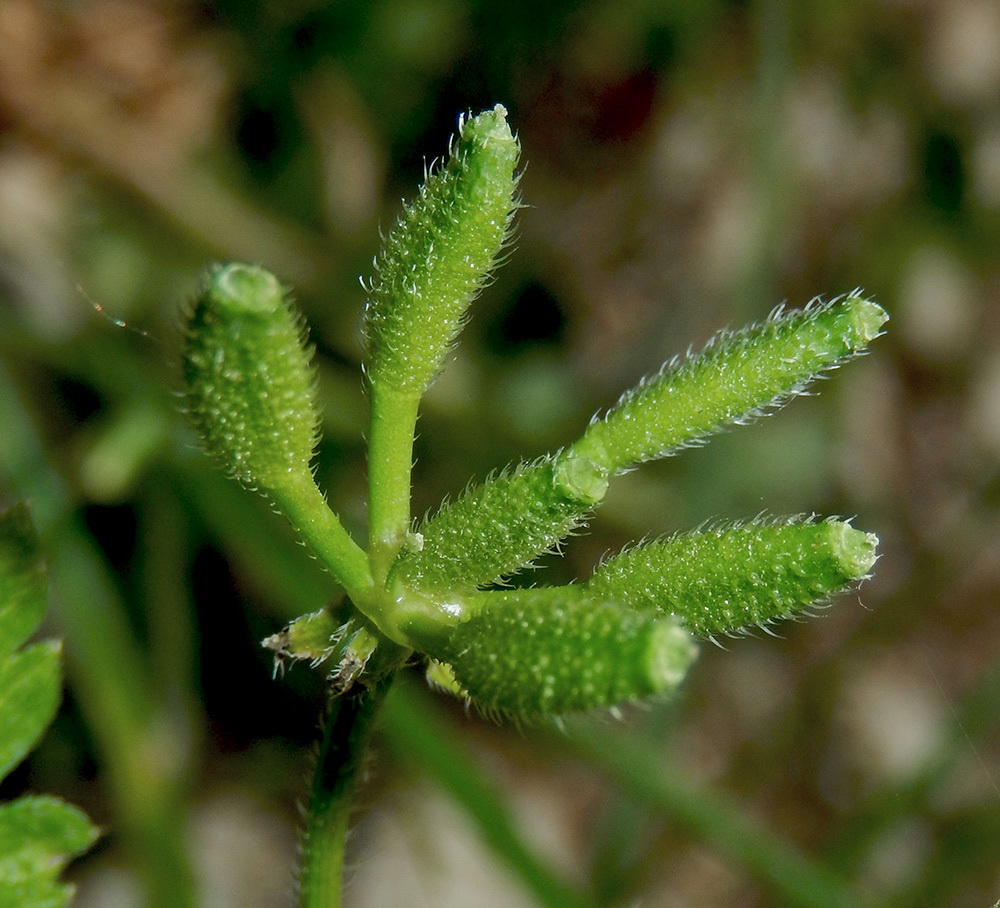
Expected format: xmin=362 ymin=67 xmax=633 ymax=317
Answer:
xmin=365 ymin=104 xmax=520 ymax=574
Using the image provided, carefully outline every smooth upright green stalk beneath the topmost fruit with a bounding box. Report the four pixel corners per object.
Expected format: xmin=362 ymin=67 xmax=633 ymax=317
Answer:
xmin=368 ymin=382 xmax=420 ymax=579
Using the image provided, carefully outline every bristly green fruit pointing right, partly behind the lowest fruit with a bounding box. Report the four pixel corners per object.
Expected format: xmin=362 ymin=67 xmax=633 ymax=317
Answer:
xmin=584 ymin=520 xmax=878 ymax=637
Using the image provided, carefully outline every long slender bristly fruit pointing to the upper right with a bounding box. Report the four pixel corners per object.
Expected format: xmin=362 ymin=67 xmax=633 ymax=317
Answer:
xmin=570 ymin=294 xmax=888 ymax=474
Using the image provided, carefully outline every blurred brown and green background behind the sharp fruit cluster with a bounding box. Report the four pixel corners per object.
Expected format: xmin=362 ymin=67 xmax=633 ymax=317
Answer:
xmin=0 ymin=0 xmax=1000 ymax=908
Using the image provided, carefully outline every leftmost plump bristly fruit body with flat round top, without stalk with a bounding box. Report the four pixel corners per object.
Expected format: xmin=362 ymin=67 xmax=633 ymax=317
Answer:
xmin=183 ymin=264 xmax=318 ymax=490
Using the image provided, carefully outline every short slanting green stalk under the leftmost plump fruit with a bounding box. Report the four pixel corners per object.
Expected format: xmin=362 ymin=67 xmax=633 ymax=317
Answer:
xmin=267 ymin=471 xmax=372 ymax=597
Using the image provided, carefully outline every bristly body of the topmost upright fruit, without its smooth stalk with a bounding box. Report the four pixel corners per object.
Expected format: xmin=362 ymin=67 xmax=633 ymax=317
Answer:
xmin=365 ymin=104 xmax=520 ymax=396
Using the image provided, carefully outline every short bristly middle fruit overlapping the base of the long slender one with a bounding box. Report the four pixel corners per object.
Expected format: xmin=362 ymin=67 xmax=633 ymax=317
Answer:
xmin=391 ymin=455 xmax=608 ymax=591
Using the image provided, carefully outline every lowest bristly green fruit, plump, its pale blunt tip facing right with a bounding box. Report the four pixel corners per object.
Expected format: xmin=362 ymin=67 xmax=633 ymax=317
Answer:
xmin=432 ymin=587 xmax=696 ymax=716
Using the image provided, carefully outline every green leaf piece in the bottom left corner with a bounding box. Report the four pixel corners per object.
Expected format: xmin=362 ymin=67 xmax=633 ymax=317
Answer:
xmin=0 ymin=796 xmax=97 ymax=908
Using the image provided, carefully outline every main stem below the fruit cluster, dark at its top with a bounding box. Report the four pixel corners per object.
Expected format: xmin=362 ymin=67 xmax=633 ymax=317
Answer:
xmin=299 ymin=672 xmax=394 ymax=908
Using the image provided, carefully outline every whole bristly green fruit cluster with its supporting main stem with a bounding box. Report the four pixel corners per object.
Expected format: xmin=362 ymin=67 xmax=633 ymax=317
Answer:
xmin=184 ymin=105 xmax=887 ymax=906
